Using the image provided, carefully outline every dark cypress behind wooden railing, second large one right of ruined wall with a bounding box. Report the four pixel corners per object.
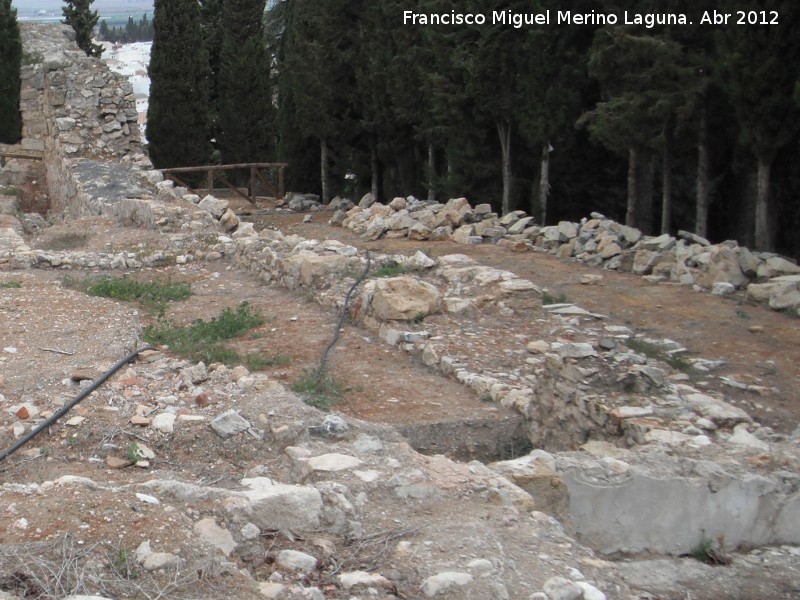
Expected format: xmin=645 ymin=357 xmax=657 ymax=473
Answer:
xmin=215 ymin=0 xmax=274 ymax=163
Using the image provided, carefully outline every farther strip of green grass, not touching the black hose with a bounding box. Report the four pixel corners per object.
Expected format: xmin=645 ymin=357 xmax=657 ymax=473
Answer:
xmin=64 ymin=276 xmax=192 ymax=314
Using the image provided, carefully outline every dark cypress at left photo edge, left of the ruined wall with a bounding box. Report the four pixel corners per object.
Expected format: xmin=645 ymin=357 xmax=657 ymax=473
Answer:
xmin=0 ymin=0 xmax=22 ymax=144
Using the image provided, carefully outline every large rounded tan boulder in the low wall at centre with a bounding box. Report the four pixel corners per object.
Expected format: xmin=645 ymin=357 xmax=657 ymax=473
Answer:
xmin=371 ymin=276 xmax=442 ymax=321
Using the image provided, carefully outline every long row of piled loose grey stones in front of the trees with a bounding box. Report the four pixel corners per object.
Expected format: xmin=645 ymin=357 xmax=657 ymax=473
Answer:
xmin=324 ymin=194 xmax=800 ymax=314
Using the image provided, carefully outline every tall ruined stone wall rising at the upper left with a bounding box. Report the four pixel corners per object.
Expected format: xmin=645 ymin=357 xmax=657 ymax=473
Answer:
xmin=3 ymin=23 xmax=146 ymax=211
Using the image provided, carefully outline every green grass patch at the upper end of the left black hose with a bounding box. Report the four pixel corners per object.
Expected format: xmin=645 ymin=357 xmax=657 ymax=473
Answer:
xmin=144 ymin=302 xmax=264 ymax=366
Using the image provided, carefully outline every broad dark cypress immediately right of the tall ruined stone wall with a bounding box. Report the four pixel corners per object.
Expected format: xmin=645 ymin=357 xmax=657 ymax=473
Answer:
xmin=147 ymin=0 xmax=210 ymax=168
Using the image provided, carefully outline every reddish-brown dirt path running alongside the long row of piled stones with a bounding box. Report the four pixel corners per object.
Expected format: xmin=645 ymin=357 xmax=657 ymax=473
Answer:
xmin=244 ymin=202 xmax=800 ymax=433
